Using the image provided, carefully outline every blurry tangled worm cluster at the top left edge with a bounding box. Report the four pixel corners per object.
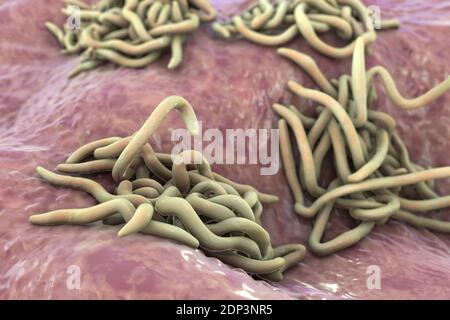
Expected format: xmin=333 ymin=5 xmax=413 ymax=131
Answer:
xmin=46 ymin=0 xmax=216 ymax=77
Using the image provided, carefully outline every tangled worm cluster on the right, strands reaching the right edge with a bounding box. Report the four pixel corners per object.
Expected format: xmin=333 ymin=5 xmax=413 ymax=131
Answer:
xmin=273 ymin=38 xmax=450 ymax=255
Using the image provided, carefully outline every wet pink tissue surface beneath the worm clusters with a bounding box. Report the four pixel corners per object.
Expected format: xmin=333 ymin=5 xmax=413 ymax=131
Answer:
xmin=0 ymin=0 xmax=450 ymax=299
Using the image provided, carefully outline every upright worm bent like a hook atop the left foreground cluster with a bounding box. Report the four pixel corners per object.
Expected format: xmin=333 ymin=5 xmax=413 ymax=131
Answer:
xmin=112 ymin=96 xmax=199 ymax=181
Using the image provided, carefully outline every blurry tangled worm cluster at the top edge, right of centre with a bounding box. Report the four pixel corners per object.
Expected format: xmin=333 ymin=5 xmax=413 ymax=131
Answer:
xmin=213 ymin=0 xmax=399 ymax=58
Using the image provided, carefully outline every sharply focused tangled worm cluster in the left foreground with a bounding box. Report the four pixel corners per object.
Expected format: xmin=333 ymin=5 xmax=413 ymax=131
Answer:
xmin=30 ymin=96 xmax=306 ymax=281
